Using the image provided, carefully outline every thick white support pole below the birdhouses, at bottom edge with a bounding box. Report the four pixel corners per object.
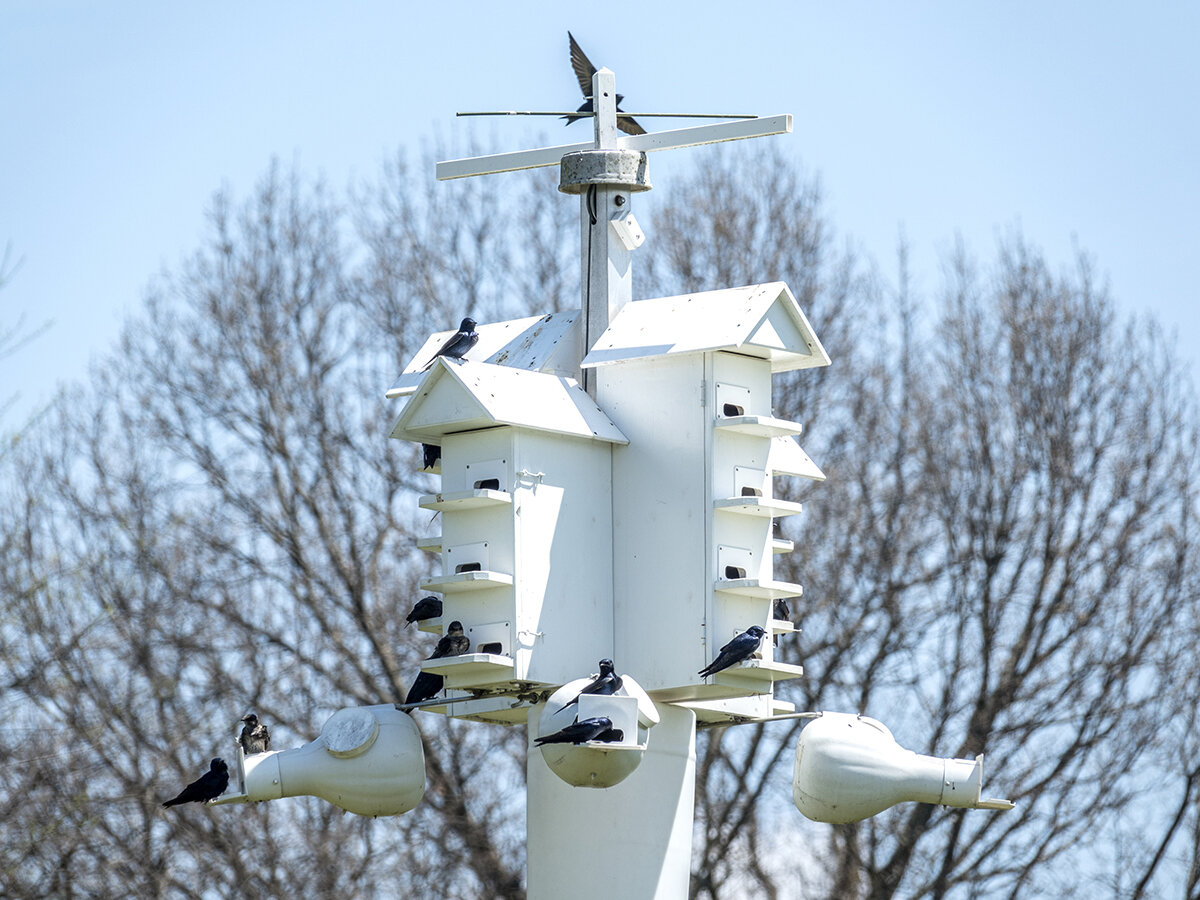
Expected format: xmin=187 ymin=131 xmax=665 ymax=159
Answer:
xmin=527 ymin=704 xmax=696 ymax=900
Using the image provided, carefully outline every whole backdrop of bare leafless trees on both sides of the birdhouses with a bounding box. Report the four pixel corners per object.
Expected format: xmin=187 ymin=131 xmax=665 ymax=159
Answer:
xmin=0 ymin=142 xmax=1200 ymax=900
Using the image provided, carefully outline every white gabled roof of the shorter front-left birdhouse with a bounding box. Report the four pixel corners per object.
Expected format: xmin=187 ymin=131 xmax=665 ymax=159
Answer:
xmin=391 ymin=358 xmax=629 ymax=444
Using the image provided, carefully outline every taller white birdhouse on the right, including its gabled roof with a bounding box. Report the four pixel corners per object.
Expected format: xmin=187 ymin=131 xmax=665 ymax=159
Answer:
xmin=582 ymin=282 xmax=829 ymax=716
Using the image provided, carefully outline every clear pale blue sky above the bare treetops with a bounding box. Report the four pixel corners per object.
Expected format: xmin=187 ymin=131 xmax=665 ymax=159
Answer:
xmin=0 ymin=0 xmax=1200 ymax=426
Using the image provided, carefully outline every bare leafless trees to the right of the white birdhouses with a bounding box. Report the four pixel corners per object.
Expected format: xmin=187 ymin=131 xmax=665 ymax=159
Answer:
xmin=655 ymin=160 xmax=1198 ymax=898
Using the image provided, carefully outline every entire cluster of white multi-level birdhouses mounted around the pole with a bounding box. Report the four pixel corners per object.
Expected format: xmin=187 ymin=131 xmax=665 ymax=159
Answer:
xmin=390 ymin=282 xmax=829 ymax=721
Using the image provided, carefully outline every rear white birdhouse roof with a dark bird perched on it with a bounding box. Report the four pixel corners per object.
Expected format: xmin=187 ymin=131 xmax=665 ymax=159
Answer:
xmin=386 ymin=310 xmax=580 ymax=397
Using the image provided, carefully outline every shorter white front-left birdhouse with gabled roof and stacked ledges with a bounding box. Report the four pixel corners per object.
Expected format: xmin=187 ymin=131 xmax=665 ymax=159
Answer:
xmin=391 ymin=352 xmax=625 ymax=720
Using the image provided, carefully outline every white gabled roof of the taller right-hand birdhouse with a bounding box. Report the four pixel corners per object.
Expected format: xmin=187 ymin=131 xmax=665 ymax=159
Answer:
xmin=583 ymin=281 xmax=829 ymax=372
